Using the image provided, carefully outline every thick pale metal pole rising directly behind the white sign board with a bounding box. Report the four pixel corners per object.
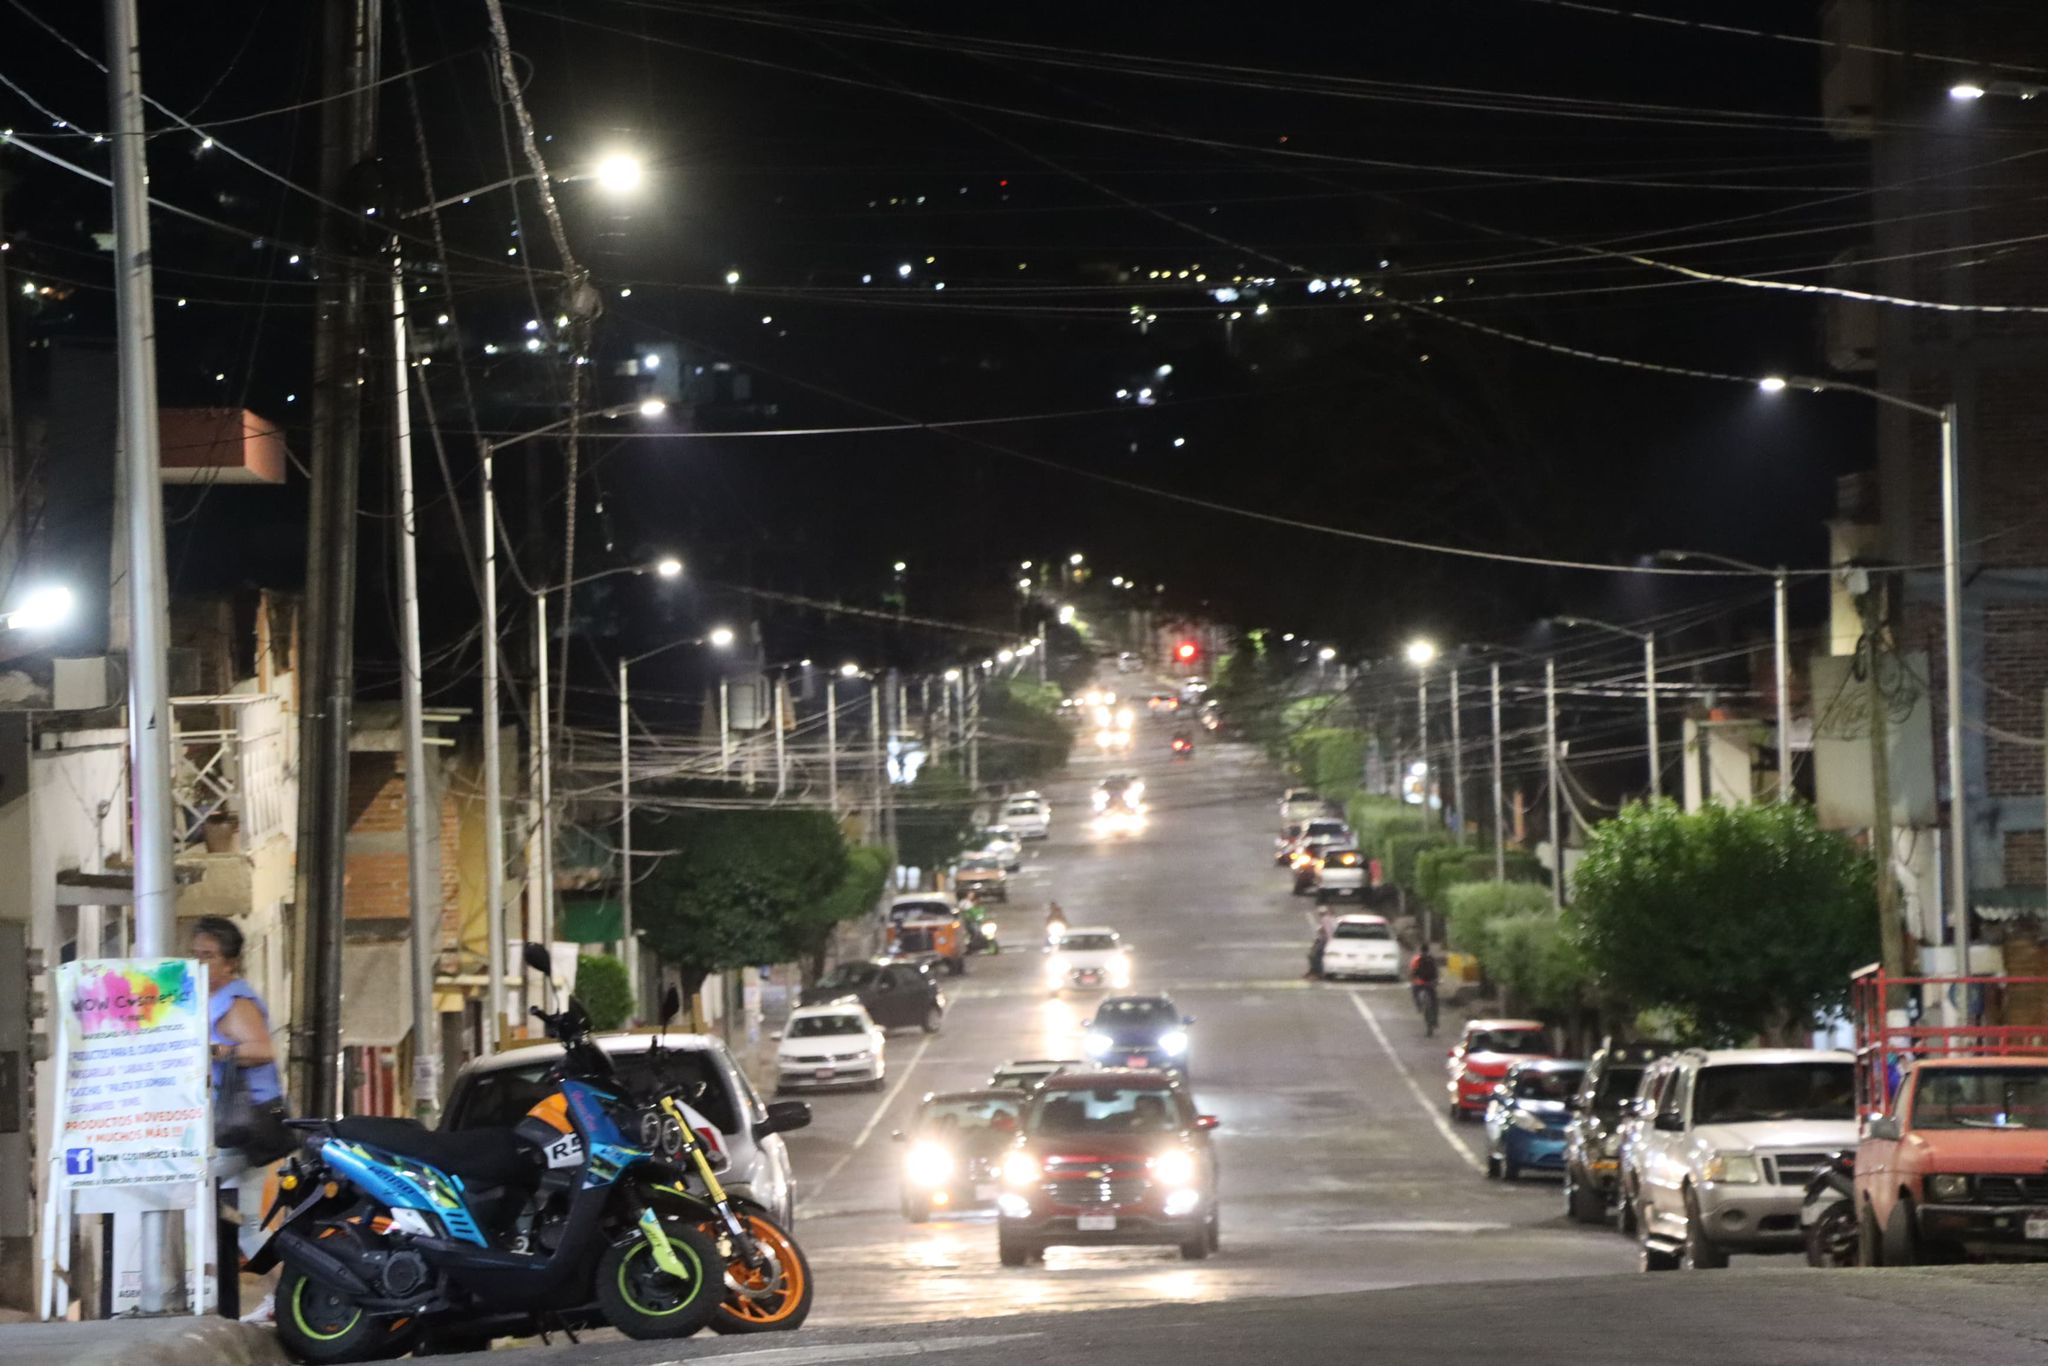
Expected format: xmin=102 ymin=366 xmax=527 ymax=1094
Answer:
xmin=104 ymin=0 xmax=179 ymax=1313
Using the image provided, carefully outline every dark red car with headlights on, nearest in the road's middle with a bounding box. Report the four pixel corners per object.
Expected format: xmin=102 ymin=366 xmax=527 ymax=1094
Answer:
xmin=995 ymin=1069 xmax=1221 ymax=1266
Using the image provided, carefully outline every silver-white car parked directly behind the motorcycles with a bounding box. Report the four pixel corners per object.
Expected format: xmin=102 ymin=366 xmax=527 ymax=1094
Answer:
xmin=440 ymin=1030 xmax=811 ymax=1229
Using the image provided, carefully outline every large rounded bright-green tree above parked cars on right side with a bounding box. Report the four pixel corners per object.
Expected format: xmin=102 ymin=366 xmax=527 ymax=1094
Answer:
xmin=1573 ymin=803 xmax=1878 ymax=1042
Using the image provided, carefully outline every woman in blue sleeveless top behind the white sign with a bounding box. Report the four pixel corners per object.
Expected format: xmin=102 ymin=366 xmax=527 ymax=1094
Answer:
xmin=190 ymin=915 xmax=289 ymax=1319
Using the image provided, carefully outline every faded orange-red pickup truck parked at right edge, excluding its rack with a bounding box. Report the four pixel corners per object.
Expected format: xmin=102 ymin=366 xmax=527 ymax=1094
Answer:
xmin=1855 ymin=1057 xmax=2048 ymax=1266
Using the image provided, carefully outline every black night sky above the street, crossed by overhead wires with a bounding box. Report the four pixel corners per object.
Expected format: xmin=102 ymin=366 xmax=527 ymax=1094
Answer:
xmin=0 ymin=0 xmax=1870 ymax=716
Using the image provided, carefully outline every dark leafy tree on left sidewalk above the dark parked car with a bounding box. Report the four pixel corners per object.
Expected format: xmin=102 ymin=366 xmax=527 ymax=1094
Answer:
xmin=633 ymin=811 xmax=846 ymax=995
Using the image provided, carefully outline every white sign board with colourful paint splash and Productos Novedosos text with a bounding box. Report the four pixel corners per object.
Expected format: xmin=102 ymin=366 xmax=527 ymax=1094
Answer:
xmin=51 ymin=958 xmax=213 ymax=1190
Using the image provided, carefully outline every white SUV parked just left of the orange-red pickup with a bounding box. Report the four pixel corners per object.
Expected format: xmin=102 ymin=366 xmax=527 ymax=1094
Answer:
xmin=1636 ymin=1049 xmax=1858 ymax=1272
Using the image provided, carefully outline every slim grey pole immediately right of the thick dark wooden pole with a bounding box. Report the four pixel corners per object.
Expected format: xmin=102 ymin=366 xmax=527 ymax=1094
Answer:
xmin=391 ymin=260 xmax=440 ymax=1126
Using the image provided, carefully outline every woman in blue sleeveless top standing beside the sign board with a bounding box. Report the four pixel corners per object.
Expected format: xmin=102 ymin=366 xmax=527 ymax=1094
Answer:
xmin=193 ymin=915 xmax=285 ymax=1319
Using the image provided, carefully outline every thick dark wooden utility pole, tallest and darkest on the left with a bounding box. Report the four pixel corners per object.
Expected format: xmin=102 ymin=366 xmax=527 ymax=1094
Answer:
xmin=292 ymin=0 xmax=383 ymax=1116
